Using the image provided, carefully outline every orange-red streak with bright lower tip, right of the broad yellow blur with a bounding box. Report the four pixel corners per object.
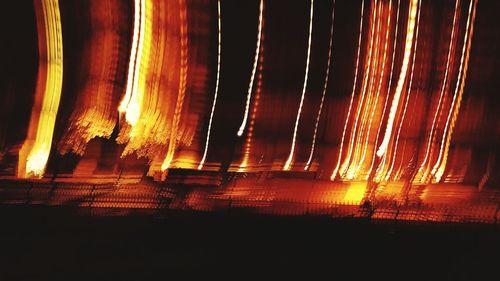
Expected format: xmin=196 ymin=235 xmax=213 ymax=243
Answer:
xmin=161 ymin=0 xmax=188 ymax=171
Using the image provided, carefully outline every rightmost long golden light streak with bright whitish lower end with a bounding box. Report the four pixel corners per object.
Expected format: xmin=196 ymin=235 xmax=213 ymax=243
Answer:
xmin=431 ymin=0 xmax=477 ymax=182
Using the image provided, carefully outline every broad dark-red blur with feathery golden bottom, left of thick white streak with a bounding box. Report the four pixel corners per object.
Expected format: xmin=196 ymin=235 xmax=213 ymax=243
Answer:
xmin=58 ymin=0 xmax=129 ymax=155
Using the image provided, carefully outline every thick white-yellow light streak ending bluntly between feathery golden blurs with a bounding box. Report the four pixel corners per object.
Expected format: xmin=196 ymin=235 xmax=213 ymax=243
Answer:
xmin=119 ymin=0 xmax=146 ymax=127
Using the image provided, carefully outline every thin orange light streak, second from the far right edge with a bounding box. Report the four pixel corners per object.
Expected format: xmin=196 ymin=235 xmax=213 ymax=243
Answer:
xmin=417 ymin=0 xmax=459 ymax=183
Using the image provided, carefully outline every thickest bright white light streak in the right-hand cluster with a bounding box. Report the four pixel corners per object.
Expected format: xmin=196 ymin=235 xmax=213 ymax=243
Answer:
xmin=377 ymin=0 xmax=418 ymax=157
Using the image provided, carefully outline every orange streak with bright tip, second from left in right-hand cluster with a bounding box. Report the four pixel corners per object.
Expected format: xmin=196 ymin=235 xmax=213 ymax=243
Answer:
xmin=340 ymin=0 xmax=377 ymax=179
